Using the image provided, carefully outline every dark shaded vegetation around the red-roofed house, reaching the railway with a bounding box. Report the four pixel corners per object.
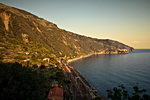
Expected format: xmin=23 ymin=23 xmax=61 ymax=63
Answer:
xmin=0 ymin=62 xmax=73 ymax=100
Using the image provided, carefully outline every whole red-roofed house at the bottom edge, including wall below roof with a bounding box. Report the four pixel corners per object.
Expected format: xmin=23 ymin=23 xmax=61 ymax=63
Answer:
xmin=48 ymin=87 xmax=63 ymax=100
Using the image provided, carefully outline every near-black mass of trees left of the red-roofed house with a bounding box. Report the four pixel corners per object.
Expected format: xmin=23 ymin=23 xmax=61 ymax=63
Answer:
xmin=0 ymin=62 xmax=48 ymax=100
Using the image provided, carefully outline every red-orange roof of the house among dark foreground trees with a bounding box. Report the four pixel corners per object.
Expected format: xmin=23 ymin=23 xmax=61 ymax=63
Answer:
xmin=48 ymin=87 xmax=63 ymax=98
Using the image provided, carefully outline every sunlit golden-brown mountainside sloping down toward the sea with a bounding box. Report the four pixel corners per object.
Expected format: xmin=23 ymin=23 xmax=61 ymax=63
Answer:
xmin=0 ymin=4 xmax=133 ymax=61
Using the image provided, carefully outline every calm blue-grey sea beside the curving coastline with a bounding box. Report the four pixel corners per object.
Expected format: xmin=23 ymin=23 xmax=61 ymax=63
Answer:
xmin=70 ymin=49 xmax=150 ymax=98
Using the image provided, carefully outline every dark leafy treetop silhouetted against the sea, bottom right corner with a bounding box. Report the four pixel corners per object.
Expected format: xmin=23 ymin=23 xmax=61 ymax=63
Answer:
xmin=106 ymin=84 xmax=150 ymax=100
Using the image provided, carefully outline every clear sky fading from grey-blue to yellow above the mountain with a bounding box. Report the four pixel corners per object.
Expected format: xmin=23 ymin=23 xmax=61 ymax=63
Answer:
xmin=0 ymin=0 xmax=150 ymax=49
